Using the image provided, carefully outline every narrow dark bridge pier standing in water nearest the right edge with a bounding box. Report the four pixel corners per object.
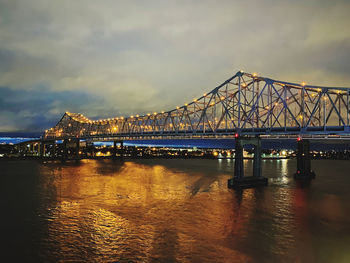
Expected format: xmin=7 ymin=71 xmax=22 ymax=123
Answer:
xmin=294 ymin=139 xmax=315 ymax=180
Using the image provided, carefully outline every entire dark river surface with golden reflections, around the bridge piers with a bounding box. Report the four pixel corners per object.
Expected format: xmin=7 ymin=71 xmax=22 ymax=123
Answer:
xmin=0 ymin=159 xmax=350 ymax=262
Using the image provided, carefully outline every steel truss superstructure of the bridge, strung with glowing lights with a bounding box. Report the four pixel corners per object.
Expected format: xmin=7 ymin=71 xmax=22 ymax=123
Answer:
xmin=43 ymin=71 xmax=350 ymax=139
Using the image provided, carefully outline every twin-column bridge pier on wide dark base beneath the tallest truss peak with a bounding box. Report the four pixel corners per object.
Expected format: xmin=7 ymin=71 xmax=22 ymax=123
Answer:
xmin=228 ymin=137 xmax=267 ymax=189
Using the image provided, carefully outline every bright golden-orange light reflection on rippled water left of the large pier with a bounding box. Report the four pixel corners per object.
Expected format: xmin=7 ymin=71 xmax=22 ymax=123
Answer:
xmin=42 ymin=160 xmax=253 ymax=262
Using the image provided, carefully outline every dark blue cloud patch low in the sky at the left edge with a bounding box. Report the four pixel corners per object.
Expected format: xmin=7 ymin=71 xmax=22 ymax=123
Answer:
xmin=0 ymin=87 xmax=103 ymax=132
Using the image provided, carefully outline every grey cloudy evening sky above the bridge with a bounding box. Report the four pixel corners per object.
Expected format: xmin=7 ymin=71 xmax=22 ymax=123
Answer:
xmin=0 ymin=0 xmax=350 ymax=131
